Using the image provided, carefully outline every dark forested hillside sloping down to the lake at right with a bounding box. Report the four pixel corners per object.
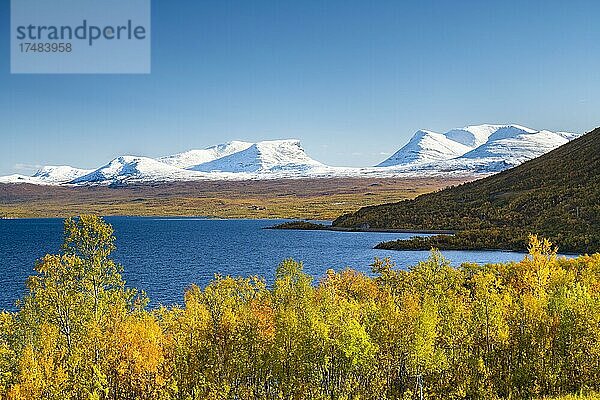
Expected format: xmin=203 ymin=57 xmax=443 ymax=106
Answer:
xmin=333 ymin=128 xmax=600 ymax=253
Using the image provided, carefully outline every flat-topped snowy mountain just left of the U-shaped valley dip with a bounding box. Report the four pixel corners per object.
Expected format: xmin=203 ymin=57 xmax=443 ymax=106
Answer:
xmin=191 ymin=139 xmax=323 ymax=173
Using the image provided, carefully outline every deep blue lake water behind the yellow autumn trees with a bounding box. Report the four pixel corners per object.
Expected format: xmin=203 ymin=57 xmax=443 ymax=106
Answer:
xmin=0 ymin=217 xmax=536 ymax=310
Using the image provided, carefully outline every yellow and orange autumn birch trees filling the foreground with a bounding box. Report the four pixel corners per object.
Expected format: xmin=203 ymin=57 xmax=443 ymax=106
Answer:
xmin=0 ymin=216 xmax=600 ymax=400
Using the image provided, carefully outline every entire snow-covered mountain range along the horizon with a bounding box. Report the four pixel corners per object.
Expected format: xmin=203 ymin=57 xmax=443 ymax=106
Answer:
xmin=0 ymin=124 xmax=579 ymax=185
